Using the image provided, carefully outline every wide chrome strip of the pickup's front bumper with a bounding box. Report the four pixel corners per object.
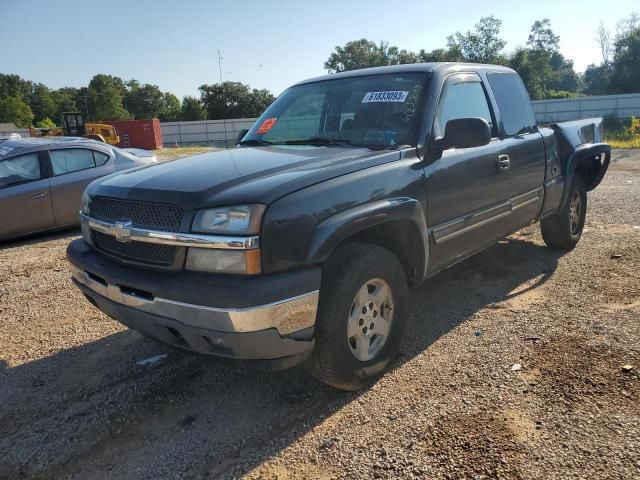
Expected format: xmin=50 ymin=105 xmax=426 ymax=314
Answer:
xmin=71 ymin=265 xmax=319 ymax=335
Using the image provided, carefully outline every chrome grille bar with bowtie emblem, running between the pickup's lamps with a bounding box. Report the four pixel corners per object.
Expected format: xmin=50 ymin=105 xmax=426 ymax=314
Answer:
xmin=80 ymin=212 xmax=260 ymax=250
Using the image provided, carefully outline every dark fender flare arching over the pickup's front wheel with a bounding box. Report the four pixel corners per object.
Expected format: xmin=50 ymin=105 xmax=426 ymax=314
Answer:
xmin=307 ymin=197 xmax=429 ymax=286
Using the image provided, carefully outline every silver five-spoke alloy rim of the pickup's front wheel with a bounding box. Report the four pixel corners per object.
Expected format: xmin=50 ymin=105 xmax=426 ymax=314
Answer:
xmin=347 ymin=278 xmax=393 ymax=362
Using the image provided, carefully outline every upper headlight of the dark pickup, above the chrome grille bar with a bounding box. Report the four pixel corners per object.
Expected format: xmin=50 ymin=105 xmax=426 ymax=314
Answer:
xmin=191 ymin=205 xmax=265 ymax=235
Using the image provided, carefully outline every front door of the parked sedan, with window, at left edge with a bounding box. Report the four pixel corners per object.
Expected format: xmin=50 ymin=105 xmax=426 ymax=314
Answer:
xmin=0 ymin=152 xmax=55 ymax=238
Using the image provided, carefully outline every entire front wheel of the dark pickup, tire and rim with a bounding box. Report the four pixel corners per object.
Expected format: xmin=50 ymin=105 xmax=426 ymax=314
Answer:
xmin=305 ymin=243 xmax=409 ymax=390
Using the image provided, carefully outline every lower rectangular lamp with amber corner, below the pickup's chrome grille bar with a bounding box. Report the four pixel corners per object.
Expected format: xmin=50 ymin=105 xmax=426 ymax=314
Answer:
xmin=186 ymin=248 xmax=262 ymax=275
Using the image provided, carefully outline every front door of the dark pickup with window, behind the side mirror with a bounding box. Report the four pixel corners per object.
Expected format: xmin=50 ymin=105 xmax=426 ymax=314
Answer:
xmin=425 ymin=73 xmax=510 ymax=271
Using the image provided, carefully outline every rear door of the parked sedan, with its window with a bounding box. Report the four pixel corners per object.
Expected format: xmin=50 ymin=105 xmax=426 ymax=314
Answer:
xmin=49 ymin=148 xmax=115 ymax=226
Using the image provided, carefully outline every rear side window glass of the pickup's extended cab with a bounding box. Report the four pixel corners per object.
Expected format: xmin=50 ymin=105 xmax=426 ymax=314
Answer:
xmin=487 ymin=72 xmax=536 ymax=137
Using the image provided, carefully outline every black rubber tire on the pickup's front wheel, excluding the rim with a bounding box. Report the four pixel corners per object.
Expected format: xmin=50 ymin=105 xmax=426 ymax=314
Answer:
xmin=305 ymin=243 xmax=409 ymax=390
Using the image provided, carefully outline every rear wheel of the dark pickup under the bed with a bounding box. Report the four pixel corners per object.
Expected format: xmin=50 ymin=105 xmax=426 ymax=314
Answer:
xmin=540 ymin=176 xmax=587 ymax=250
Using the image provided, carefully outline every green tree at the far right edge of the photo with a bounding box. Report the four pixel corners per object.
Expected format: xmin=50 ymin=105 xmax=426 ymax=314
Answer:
xmin=609 ymin=28 xmax=640 ymax=93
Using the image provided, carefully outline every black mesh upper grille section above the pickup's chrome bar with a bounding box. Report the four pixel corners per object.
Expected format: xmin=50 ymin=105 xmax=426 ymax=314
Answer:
xmin=90 ymin=197 xmax=184 ymax=232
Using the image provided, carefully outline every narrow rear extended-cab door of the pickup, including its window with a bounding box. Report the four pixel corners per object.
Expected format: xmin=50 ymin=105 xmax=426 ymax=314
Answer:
xmin=487 ymin=72 xmax=546 ymax=232
